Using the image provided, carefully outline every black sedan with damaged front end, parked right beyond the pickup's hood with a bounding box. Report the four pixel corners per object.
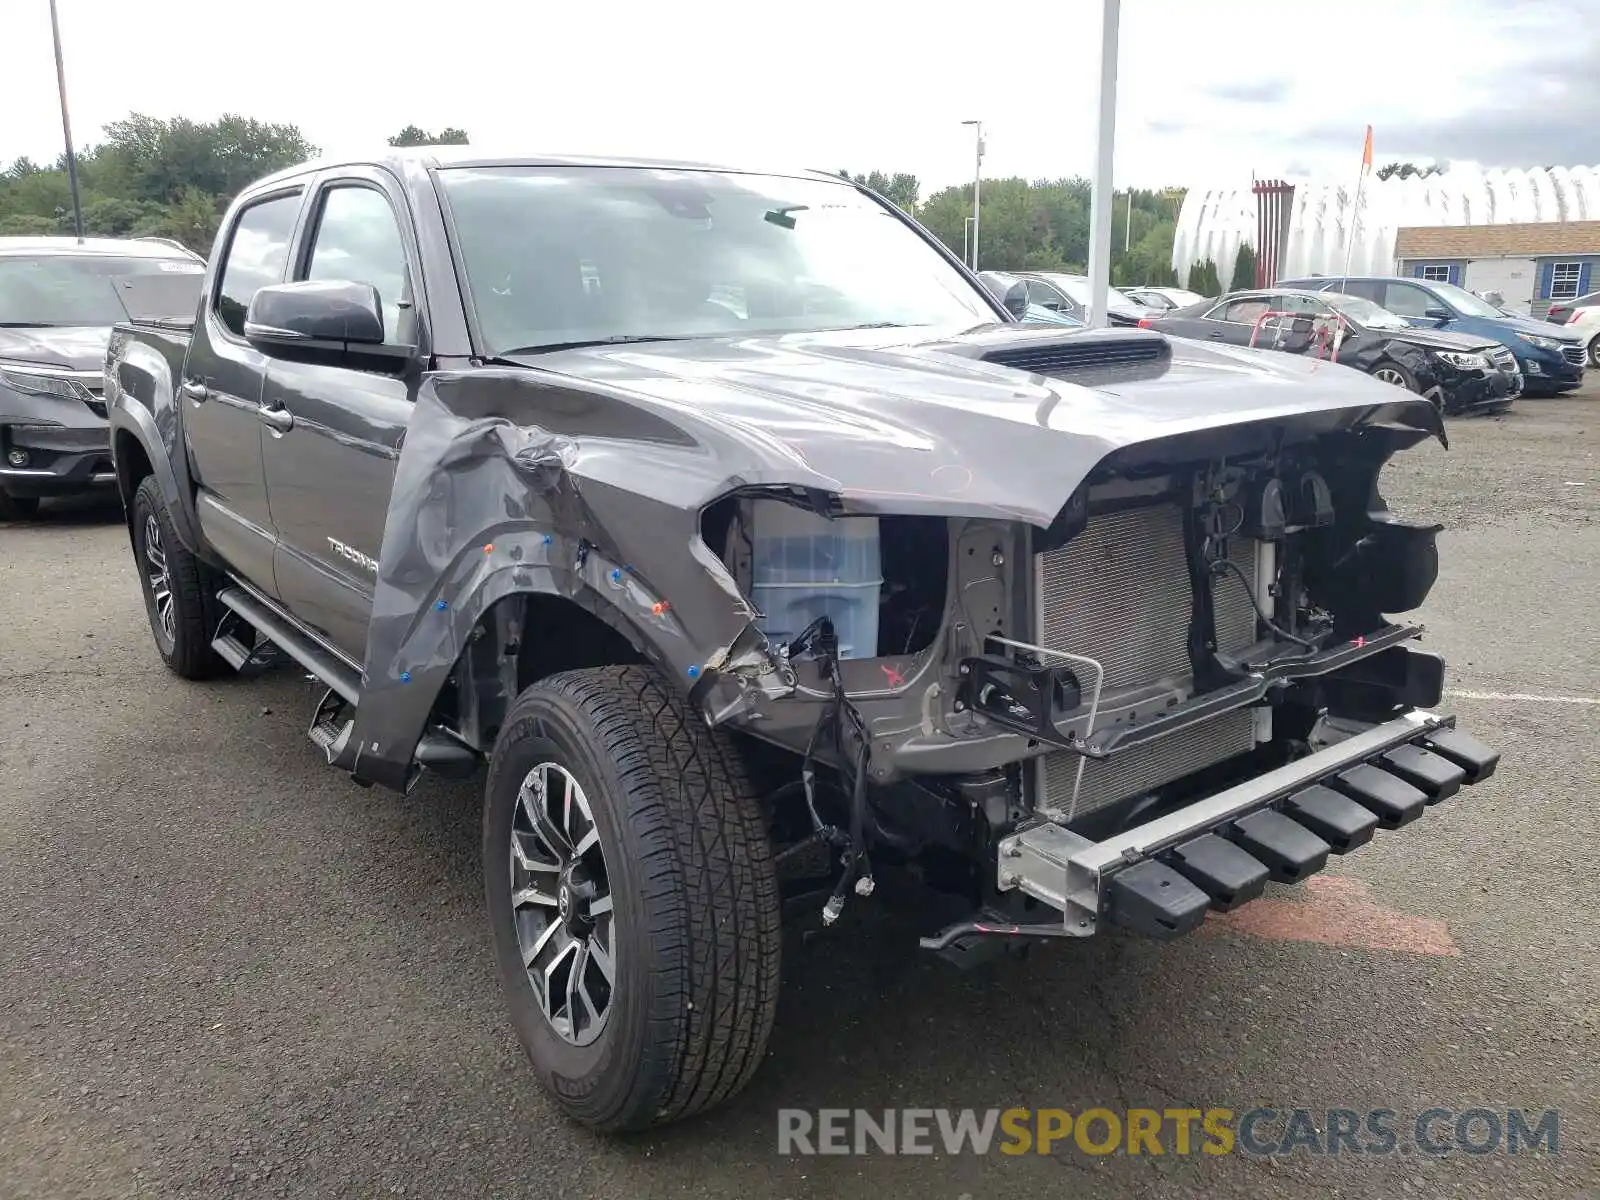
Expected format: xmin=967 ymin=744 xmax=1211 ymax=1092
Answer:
xmin=1139 ymin=288 xmax=1522 ymax=413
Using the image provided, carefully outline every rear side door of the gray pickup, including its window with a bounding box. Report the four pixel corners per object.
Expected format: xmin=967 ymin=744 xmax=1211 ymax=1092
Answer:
xmin=178 ymin=186 xmax=306 ymax=595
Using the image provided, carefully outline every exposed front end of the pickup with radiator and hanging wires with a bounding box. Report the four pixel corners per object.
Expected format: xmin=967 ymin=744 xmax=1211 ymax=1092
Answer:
xmin=702 ymin=426 xmax=1442 ymax=918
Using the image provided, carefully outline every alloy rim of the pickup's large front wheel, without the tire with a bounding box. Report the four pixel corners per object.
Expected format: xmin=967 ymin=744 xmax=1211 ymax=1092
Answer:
xmin=510 ymin=762 xmax=616 ymax=1046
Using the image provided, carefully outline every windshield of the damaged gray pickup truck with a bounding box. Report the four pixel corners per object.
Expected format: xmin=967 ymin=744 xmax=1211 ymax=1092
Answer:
xmin=438 ymin=166 xmax=1003 ymax=355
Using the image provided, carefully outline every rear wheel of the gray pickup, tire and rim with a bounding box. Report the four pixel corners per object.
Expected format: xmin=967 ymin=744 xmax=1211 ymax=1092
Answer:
xmin=131 ymin=475 xmax=227 ymax=678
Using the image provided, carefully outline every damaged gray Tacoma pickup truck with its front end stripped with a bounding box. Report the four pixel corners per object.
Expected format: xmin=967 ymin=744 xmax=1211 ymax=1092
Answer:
xmin=106 ymin=147 xmax=1498 ymax=1130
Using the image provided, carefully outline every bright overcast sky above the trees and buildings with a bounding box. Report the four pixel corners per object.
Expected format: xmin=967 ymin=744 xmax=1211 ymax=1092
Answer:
xmin=0 ymin=0 xmax=1600 ymax=195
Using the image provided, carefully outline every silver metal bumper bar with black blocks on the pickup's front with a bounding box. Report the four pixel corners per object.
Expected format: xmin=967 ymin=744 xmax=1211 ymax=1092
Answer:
xmin=997 ymin=709 xmax=1499 ymax=938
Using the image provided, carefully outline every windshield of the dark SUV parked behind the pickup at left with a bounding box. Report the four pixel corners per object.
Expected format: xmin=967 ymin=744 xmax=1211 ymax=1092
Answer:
xmin=0 ymin=254 xmax=205 ymax=326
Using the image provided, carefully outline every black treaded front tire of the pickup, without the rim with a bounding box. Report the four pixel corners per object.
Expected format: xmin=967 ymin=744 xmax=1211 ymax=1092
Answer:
xmin=483 ymin=666 xmax=781 ymax=1131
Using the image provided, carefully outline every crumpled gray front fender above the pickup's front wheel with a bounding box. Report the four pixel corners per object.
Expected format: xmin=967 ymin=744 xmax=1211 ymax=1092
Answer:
xmin=352 ymin=371 xmax=776 ymax=786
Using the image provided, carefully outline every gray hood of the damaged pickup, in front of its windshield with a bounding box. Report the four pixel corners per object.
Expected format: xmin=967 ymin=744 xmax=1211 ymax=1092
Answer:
xmin=510 ymin=325 xmax=1443 ymax=526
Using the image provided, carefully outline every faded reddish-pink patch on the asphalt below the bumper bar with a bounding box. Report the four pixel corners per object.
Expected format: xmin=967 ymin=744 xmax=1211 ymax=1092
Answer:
xmin=1200 ymin=875 xmax=1461 ymax=958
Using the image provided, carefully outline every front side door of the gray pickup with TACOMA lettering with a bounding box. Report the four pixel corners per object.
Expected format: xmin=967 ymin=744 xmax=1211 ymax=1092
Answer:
xmin=262 ymin=168 xmax=424 ymax=662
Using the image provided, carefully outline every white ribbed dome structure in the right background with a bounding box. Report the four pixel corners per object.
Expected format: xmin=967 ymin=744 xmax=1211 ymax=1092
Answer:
xmin=1173 ymin=165 xmax=1600 ymax=282
